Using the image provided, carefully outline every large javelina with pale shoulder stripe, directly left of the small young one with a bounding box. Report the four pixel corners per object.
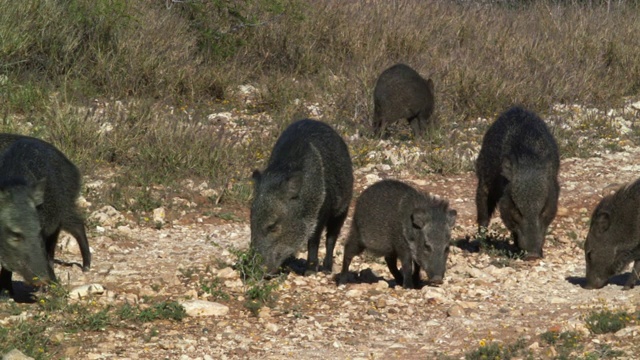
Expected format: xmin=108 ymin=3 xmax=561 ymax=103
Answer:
xmin=251 ymin=119 xmax=353 ymax=273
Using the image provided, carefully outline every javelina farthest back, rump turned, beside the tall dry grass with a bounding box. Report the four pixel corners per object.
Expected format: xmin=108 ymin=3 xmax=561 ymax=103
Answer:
xmin=373 ymin=64 xmax=434 ymax=136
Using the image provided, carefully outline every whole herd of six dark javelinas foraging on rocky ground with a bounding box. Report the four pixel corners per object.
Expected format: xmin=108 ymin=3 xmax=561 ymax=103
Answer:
xmin=0 ymin=64 xmax=640 ymax=296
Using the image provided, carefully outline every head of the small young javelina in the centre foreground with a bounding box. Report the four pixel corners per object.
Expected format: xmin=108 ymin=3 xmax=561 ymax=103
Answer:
xmin=408 ymin=202 xmax=457 ymax=284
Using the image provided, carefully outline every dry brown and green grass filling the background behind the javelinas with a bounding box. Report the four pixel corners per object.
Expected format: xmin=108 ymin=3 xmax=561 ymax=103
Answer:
xmin=0 ymin=0 xmax=640 ymax=357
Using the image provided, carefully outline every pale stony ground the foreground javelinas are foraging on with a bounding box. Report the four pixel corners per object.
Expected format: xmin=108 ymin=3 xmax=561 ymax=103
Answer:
xmin=0 ymin=100 xmax=640 ymax=359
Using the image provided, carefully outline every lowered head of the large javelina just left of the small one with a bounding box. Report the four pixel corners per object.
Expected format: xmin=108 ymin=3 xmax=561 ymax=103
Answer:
xmin=251 ymin=170 xmax=310 ymax=273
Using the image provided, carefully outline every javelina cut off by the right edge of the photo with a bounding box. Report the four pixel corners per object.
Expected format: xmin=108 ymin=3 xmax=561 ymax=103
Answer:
xmin=584 ymin=179 xmax=640 ymax=290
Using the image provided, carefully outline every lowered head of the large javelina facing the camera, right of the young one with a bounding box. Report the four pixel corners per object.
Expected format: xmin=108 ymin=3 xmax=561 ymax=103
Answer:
xmin=500 ymin=160 xmax=558 ymax=259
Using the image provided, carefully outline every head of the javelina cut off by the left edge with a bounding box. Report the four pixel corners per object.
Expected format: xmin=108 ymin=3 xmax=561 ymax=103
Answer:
xmin=0 ymin=180 xmax=56 ymax=284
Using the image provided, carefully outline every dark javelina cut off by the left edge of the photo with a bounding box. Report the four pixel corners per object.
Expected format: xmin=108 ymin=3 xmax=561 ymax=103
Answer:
xmin=0 ymin=138 xmax=91 ymax=293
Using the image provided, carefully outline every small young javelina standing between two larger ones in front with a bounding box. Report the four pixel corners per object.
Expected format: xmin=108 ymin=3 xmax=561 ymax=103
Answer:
xmin=337 ymin=180 xmax=456 ymax=289
